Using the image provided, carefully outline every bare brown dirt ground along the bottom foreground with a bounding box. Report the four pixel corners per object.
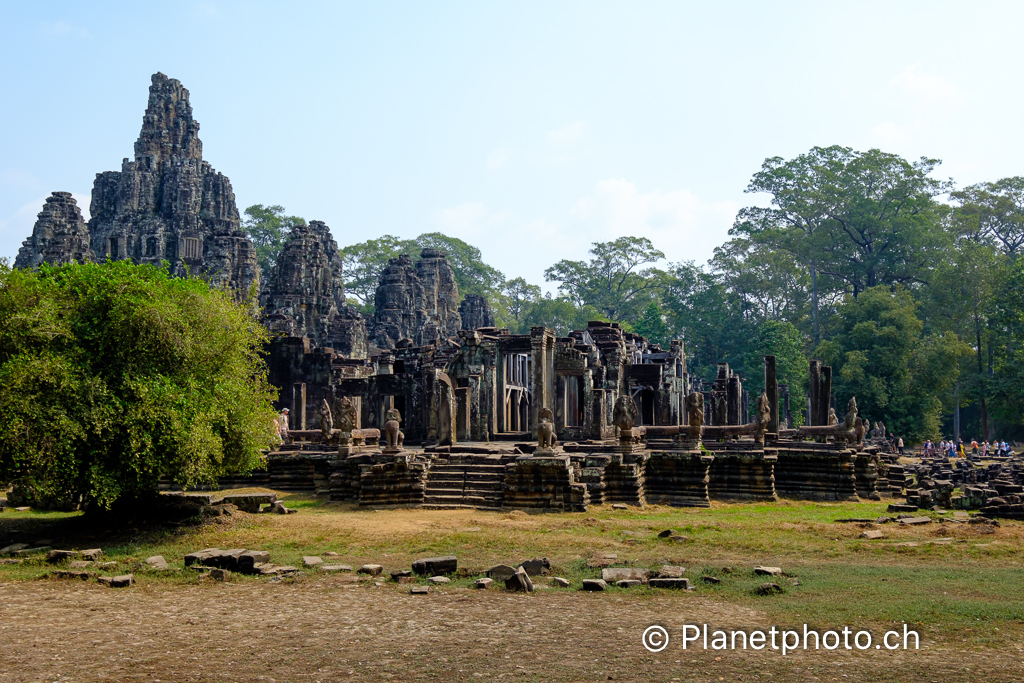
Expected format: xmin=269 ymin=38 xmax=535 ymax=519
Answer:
xmin=0 ymin=575 xmax=1024 ymax=683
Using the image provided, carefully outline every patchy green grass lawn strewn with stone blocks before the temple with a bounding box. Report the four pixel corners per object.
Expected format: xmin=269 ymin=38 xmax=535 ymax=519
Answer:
xmin=0 ymin=494 xmax=1024 ymax=683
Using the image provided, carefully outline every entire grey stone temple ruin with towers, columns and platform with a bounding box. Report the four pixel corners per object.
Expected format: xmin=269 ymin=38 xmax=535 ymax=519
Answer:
xmin=15 ymin=74 xmax=1024 ymax=518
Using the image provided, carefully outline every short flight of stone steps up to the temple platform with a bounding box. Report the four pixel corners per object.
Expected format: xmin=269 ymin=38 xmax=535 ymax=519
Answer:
xmin=423 ymin=458 xmax=505 ymax=509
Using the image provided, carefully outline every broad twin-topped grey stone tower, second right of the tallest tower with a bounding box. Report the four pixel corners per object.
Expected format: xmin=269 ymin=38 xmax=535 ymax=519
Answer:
xmin=371 ymin=248 xmax=462 ymax=349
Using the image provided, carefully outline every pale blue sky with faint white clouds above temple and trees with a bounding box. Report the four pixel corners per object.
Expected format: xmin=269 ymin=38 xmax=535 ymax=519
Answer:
xmin=0 ymin=0 xmax=1024 ymax=288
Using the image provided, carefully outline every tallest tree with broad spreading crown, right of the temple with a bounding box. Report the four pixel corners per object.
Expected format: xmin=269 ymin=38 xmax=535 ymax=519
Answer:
xmin=730 ymin=145 xmax=951 ymax=343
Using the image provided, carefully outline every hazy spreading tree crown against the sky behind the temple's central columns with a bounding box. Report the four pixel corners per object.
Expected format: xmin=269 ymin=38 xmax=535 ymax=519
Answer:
xmin=544 ymin=237 xmax=665 ymax=322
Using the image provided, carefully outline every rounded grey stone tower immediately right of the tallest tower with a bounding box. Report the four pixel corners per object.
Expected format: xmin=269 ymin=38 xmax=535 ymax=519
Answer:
xmin=260 ymin=220 xmax=368 ymax=358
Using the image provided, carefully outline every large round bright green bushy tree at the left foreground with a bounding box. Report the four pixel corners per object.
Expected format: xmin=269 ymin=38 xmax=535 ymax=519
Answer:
xmin=0 ymin=261 xmax=276 ymax=509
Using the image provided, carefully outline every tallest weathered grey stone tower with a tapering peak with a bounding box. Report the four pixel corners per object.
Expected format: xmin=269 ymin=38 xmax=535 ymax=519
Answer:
xmin=89 ymin=74 xmax=260 ymax=299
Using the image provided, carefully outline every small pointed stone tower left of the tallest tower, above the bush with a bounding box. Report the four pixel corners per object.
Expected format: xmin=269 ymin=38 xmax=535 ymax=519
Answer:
xmin=14 ymin=193 xmax=93 ymax=268
